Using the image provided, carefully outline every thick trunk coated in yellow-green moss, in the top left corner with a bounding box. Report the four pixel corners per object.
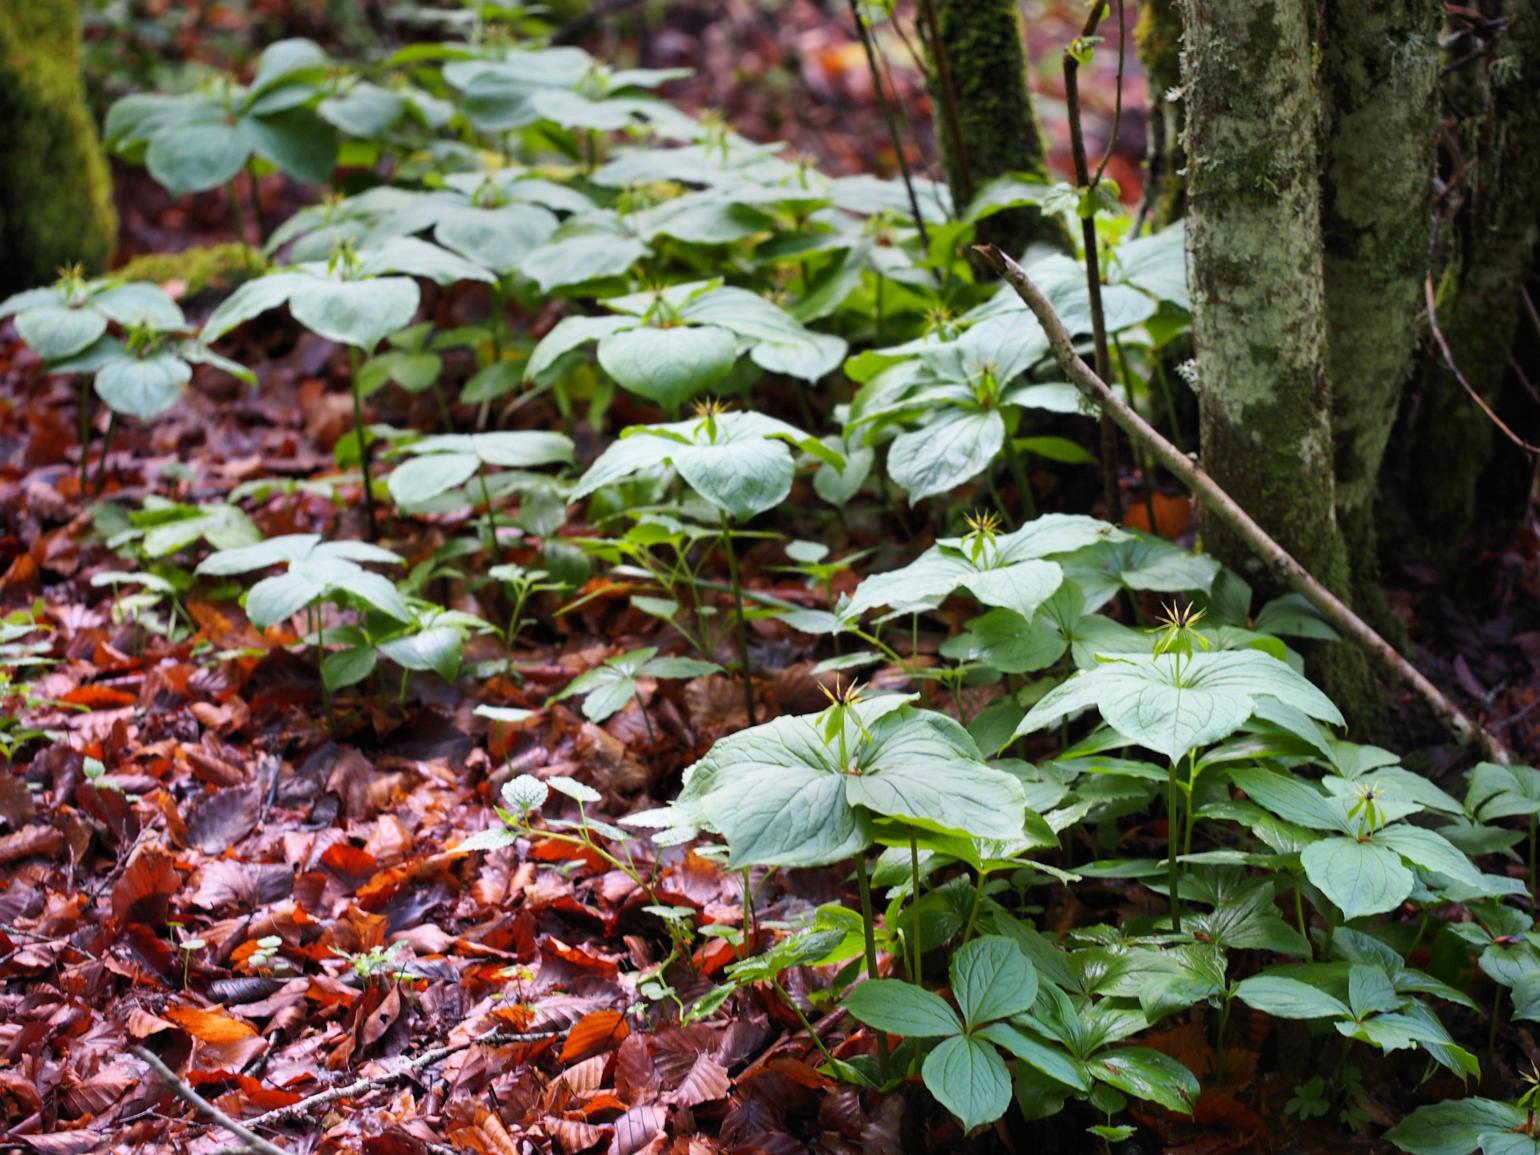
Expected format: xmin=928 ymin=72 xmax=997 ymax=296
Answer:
xmin=0 ymin=0 xmax=117 ymax=296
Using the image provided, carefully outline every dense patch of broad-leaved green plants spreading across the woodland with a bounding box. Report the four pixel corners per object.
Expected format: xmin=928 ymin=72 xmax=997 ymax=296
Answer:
xmin=15 ymin=9 xmax=1540 ymax=1155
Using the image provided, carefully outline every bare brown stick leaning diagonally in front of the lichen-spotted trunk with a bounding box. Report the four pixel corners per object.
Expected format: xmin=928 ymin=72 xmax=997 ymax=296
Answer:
xmin=976 ymin=245 xmax=1511 ymax=764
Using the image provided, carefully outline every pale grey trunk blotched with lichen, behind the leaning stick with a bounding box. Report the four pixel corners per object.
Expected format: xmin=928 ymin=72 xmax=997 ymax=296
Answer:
xmin=1181 ymin=0 xmax=1381 ymax=727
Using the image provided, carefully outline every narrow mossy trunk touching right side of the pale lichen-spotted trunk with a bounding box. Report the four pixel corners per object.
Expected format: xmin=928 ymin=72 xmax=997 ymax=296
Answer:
xmin=1320 ymin=0 xmax=1443 ymax=634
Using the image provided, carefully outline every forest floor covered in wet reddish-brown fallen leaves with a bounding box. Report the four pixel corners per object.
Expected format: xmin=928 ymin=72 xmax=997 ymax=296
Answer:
xmin=0 ymin=0 xmax=1540 ymax=1155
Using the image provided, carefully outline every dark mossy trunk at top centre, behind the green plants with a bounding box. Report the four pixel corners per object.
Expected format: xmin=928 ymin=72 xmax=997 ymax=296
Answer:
xmin=919 ymin=0 xmax=1070 ymax=256
